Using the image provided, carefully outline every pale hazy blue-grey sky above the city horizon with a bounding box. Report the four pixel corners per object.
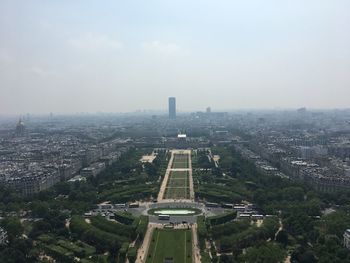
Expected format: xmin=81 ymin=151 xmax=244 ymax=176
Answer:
xmin=0 ymin=0 xmax=350 ymax=114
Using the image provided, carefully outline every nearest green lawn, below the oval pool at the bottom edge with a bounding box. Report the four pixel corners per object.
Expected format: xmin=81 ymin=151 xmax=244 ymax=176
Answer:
xmin=146 ymin=229 xmax=192 ymax=263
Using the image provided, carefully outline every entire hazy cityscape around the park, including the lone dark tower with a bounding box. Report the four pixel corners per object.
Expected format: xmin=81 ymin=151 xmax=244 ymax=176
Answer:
xmin=0 ymin=108 xmax=350 ymax=195
